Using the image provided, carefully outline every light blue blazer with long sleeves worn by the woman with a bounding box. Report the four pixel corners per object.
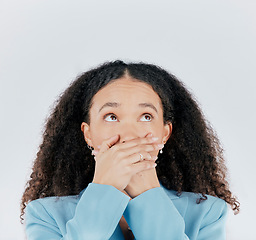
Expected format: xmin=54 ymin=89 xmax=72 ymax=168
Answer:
xmin=25 ymin=183 xmax=227 ymax=240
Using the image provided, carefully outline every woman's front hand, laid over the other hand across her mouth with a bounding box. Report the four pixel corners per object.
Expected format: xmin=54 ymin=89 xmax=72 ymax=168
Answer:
xmin=93 ymin=135 xmax=160 ymax=191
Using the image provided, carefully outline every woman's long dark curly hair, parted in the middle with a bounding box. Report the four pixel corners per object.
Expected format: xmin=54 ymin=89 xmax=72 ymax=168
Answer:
xmin=20 ymin=61 xmax=239 ymax=220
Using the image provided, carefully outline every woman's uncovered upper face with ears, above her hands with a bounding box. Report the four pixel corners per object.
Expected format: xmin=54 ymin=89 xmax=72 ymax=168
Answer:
xmin=81 ymin=77 xmax=172 ymax=155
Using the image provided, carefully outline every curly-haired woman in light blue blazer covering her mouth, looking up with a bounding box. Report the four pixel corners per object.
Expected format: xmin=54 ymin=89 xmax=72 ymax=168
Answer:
xmin=21 ymin=61 xmax=239 ymax=240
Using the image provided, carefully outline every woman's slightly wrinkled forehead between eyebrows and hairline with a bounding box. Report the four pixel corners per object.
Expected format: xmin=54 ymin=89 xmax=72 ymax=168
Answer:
xmin=92 ymin=77 xmax=162 ymax=107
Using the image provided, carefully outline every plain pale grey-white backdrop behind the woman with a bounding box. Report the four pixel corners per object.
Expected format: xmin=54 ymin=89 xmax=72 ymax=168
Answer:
xmin=0 ymin=0 xmax=256 ymax=240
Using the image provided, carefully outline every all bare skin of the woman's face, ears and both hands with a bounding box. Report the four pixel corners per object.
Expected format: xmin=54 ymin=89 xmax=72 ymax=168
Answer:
xmin=81 ymin=76 xmax=172 ymax=198
